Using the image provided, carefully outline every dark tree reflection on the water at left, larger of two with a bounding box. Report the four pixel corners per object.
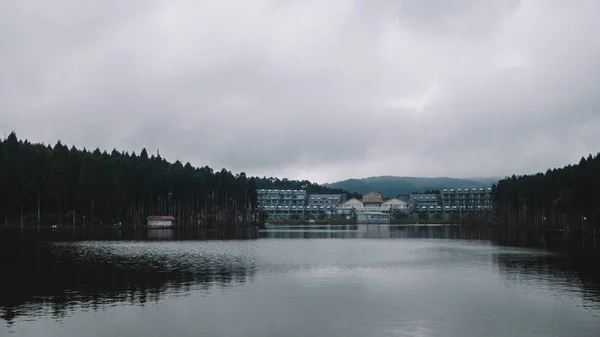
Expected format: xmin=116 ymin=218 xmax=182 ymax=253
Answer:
xmin=0 ymin=232 xmax=254 ymax=323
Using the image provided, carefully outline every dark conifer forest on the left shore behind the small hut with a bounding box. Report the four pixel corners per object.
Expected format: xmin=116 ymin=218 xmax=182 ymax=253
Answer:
xmin=0 ymin=133 xmax=256 ymax=227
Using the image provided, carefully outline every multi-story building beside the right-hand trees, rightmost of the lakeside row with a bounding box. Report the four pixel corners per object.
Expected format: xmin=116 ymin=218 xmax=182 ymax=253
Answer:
xmin=440 ymin=187 xmax=492 ymax=211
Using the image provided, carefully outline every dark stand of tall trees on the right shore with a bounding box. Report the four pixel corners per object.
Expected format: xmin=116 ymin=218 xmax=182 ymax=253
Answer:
xmin=493 ymin=153 xmax=600 ymax=230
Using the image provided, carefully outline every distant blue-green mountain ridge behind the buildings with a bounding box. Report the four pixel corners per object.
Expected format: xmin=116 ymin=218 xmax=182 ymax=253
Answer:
xmin=325 ymin=176 xmax=499 ymax=198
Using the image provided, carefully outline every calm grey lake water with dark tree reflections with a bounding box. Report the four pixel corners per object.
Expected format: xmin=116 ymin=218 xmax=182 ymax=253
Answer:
xmin=0 ymin=225 xmax=600 ymax=337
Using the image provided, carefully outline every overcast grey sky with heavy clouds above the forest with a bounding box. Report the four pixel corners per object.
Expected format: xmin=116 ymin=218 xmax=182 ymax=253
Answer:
xmin=0 ymin=0 xmax=600 ymax=182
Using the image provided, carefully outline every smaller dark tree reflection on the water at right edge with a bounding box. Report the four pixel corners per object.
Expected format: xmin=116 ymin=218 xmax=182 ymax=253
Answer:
xmin=493 ymin=250 xmax=600 ymax=309
